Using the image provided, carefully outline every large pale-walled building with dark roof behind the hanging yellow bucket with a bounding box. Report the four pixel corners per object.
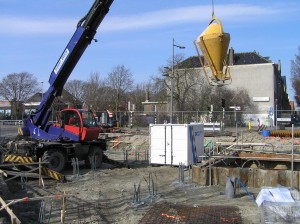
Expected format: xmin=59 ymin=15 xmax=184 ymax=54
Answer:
xmin=174 ymin=48 xmax=291 ymax=125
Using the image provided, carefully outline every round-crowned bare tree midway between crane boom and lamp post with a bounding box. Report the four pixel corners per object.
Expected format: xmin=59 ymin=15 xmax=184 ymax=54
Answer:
xmin=107 ymin=65 xmax=133 ymax=111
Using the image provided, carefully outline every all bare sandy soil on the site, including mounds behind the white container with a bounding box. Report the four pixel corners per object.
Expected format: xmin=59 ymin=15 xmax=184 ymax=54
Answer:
xmin=0 ymin=129 xmax=298 ymax=224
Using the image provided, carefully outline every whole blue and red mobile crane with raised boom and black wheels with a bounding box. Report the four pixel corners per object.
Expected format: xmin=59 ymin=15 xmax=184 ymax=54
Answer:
xmin=6 ymin=0 xmax=113 ymax=172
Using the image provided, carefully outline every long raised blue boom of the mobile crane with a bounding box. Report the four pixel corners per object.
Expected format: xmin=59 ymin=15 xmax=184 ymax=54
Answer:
xmin=23 ymin=0 xmax=113 ymax=136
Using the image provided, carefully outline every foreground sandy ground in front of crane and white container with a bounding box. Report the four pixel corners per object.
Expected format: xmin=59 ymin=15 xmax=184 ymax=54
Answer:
xmin=0 ymin=166 xmax=260 ymax=224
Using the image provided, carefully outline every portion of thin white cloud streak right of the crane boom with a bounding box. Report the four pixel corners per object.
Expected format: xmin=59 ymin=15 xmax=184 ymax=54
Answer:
xmin=105 ymin=5 xmax=276 ymax=30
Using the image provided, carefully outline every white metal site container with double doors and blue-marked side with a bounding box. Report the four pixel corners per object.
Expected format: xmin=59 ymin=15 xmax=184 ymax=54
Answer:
xmin=149 ymin=123 xmax=204 ymax=166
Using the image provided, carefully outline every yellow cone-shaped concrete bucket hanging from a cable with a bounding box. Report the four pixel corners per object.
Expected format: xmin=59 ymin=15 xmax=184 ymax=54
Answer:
xmin=194 ymin=16 xmax=231 ymax=85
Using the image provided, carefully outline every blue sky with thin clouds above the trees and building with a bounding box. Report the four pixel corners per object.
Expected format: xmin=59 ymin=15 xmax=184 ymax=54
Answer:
xmin=0 ymin=0 xmax=300 ymax=100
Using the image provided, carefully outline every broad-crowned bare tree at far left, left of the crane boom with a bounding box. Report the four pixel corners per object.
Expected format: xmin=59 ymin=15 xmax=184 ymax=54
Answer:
xmin=0 ymin=72 xmax=41 ymax=119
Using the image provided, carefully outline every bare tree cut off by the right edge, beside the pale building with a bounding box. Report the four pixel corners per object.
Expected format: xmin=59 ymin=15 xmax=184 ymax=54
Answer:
xmin=291 ymin=47 xmax=300 ymax=105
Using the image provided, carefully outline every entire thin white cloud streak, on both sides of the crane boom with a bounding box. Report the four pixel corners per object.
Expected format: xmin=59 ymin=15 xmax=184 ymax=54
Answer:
xmin=0 ymin=4 xmax=290 ymax=35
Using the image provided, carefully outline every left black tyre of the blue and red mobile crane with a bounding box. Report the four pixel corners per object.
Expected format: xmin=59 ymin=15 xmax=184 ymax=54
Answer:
xmin=42 ymin=149 xmax=66 ymax=172
